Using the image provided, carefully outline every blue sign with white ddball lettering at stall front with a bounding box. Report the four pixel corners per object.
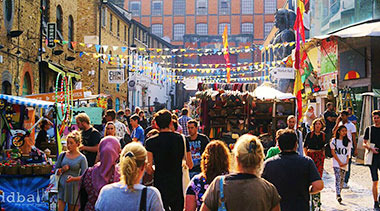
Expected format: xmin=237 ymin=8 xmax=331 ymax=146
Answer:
xmin=0 ymin=176 xmax=49 ymax=211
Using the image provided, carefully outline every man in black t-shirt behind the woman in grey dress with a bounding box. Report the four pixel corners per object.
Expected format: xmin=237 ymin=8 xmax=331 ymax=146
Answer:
xmin=75 ymin=113 xmax=101 ymax=167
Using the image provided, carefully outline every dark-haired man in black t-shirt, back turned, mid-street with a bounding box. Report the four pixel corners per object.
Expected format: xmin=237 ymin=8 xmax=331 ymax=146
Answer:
xmin=145 ymin=110 xmax=193 ymax=210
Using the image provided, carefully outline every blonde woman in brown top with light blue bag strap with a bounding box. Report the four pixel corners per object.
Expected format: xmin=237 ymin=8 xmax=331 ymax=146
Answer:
xmin=201 ymin=134 xmax=280 ymax=211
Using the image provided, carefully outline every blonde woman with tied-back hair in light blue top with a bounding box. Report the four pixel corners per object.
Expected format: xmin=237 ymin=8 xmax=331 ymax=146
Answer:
xmin=95 ymin=142 xmax=164 ymax=211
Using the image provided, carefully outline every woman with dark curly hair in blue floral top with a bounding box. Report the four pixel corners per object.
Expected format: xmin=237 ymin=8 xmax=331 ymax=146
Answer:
xmin=185 ymin=141 xmax=230 ymax=211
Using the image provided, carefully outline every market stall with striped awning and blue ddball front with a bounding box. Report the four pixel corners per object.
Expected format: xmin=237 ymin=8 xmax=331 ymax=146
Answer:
xmin=0 ymin=94 xmax=59 ymax=211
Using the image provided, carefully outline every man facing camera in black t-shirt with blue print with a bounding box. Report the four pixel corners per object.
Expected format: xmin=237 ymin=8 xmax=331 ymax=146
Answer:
xmin=186 ymin=119 xmax=210 ymax=179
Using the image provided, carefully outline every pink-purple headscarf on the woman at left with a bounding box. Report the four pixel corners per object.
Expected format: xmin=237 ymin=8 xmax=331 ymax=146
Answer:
xmin=91 ymin=136 xmax=120 ymax=193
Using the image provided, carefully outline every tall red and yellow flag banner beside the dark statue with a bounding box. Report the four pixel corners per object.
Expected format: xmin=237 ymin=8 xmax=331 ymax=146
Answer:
xmin=293 ymin=0 xmax=305 ymax=123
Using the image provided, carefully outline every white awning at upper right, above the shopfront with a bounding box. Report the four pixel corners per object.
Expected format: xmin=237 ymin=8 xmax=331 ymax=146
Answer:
xmin=315 ymin=21 xmax=380 ymax=39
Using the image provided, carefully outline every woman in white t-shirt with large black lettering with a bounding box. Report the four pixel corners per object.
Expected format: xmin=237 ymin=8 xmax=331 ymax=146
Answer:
xmin=330 ymin=125 xmax=352 ymax=203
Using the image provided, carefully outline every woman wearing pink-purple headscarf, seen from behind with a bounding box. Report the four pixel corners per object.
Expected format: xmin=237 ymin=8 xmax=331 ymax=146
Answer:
xmin=81 ymin=136 xmax=121 ymax=211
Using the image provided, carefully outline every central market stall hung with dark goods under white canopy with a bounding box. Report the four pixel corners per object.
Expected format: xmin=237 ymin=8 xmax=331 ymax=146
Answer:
xmin=192 ymin=84 xmax=295 ymax=150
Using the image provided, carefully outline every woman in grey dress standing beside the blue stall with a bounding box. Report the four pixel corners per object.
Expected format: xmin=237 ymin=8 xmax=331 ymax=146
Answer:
xmin=56 ymin=131 xmax=87 ymax=211
